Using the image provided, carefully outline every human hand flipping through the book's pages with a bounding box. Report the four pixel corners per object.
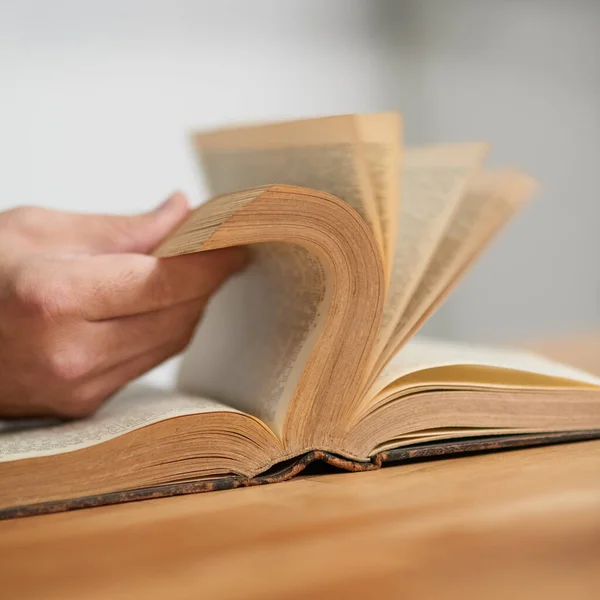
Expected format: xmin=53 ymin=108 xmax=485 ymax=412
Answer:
xmin=0 ymin=194 xmax=247 ymax=418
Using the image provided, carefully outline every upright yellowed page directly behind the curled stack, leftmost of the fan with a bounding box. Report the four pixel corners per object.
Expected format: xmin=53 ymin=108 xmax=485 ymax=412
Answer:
xmin=194 ymin=115 xmax=384 ymax=256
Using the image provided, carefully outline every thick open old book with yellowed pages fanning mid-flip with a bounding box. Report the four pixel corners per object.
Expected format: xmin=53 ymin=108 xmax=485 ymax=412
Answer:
xmin=0 ymin=113 xmax=600 ymax=517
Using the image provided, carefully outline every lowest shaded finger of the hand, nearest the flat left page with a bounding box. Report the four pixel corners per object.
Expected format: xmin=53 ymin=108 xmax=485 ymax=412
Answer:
xmin=62 ymin=342 xmax=190 ymax=418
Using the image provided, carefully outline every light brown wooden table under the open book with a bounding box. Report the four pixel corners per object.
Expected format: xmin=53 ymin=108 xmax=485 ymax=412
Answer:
xmin=0 ymin=337 xmax=600 ymax=600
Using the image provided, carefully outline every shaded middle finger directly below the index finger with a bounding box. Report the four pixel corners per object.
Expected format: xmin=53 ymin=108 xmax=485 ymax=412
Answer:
xmin=81 ymin=299 xmax=206 ymax=376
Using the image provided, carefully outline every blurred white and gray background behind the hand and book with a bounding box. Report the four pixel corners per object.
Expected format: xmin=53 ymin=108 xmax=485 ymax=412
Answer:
xmin=0 ymin=0 xmax=600 ymax=380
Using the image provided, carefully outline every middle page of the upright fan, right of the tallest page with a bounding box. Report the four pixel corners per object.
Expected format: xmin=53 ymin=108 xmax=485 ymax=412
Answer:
xmin=377 ymin=144 xmax=487 ymax=351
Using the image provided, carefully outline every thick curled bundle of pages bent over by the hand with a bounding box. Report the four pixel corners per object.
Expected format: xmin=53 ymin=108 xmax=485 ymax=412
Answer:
xmin=162 ymin=185 xmax=385 ymax=452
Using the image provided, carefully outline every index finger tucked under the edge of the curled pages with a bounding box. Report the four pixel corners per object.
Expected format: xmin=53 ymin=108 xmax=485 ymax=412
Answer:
xmin=53 ymin=248 xmax=248 ymax=321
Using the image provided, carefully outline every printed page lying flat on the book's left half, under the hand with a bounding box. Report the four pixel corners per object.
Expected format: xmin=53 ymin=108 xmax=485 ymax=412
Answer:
xmin=0 ymin=383 xmax=244 ymax=462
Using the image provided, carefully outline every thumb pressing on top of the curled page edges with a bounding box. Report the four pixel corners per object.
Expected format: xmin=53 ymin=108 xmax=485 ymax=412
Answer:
xmin=82 ymin=192 xmax=190 ymax=254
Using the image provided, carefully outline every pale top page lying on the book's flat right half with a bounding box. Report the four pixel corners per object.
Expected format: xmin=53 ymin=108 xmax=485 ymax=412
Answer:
xmin=370 ymin=337 xmax=600 ymax=395
